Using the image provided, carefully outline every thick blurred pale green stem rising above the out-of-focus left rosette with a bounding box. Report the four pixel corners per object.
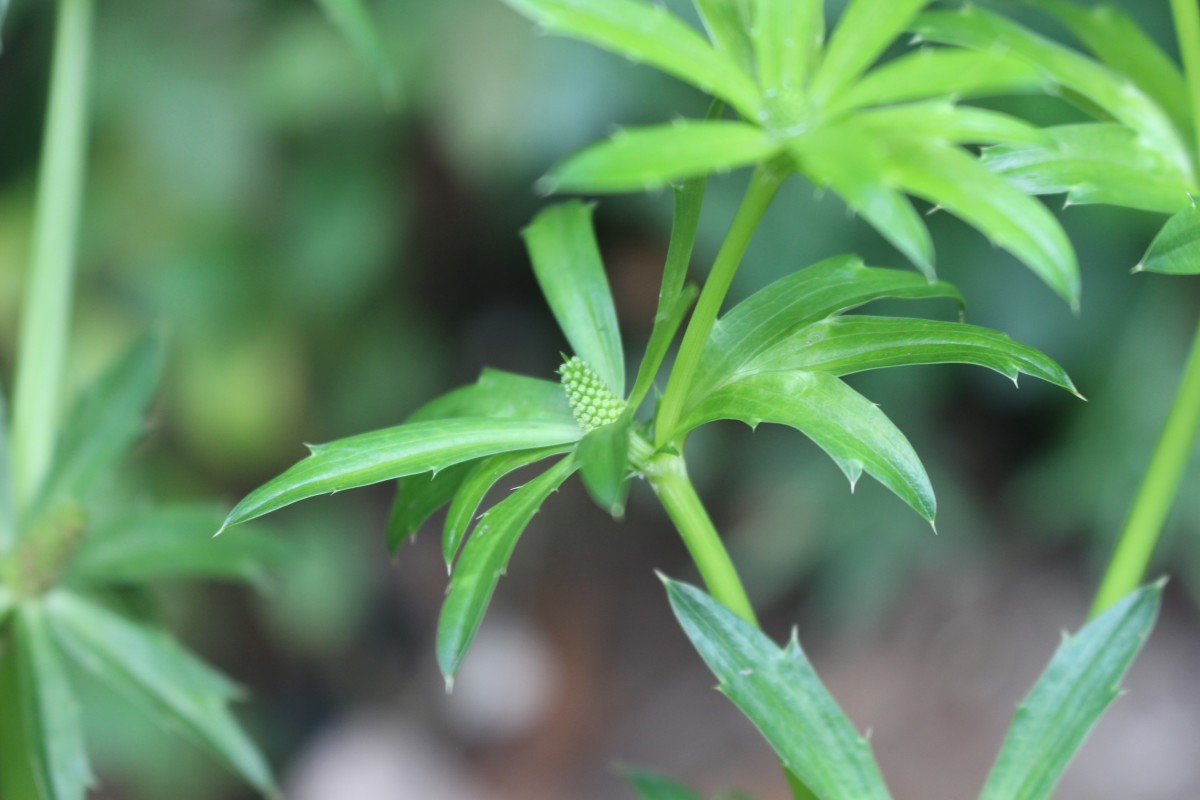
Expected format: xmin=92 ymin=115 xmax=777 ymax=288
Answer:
xmin=12 ymin=0 xmax=92 ymax=510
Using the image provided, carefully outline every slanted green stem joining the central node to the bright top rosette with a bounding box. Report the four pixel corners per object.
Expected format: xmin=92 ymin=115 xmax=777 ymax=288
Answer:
xmin=654 ymin=164 xmax=787 ymax=446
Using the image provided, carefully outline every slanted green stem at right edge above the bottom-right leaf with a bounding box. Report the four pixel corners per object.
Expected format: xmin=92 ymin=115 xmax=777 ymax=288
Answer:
xmin=1092 ymin=316 xmax=1200 ymax=616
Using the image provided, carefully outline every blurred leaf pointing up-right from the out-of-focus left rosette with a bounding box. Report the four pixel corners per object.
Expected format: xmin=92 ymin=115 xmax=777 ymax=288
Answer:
xmin=30 ymin=337 xmax=163 ymax=527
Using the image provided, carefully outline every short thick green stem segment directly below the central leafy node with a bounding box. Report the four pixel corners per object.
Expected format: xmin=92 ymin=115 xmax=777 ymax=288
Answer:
xmin=646 ymin=453 xmax=758 ymax=627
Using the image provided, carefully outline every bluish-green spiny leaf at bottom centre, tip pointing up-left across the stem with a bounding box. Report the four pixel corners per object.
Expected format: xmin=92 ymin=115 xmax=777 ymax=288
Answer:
xmin=664 ymin=578 xmax=889 ymax=800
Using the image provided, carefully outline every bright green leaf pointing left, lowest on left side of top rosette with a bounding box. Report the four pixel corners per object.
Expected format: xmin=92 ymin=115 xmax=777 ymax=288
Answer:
xmin=540 ymin=120 xmax=780 ymax=192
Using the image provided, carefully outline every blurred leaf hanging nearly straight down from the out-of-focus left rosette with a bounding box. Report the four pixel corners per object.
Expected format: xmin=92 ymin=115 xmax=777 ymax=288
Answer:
xmin=14 ymin=603 xmax=92 ymax=800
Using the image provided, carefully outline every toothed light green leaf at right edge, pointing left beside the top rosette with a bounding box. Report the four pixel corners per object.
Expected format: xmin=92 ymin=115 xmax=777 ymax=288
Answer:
xmin=982 ymin=122 xmax=1194 ymax=213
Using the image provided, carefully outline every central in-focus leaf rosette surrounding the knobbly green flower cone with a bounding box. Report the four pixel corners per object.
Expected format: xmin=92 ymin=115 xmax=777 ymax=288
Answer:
xmin=226 ymin=199 xmax=1072 ymax=681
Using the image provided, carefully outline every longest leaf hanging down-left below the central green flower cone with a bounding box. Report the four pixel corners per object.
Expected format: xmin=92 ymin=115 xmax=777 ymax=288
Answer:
xmin=437 ymin=456 xmax=576 ymax=690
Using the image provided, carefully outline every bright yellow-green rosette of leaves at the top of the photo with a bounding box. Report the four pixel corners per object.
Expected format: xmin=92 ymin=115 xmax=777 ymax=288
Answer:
xmin=505 ymin=0 xmax=1079 ymax=305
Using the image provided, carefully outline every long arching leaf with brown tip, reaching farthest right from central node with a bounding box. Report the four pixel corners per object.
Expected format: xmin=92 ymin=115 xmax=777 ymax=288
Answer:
xmin=745 ymin=314 xmax=1078 ymax=393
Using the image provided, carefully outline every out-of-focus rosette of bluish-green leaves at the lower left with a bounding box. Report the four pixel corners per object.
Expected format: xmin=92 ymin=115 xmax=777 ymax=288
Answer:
xmin=0 ymin=339 xmax=276 ymax=800
